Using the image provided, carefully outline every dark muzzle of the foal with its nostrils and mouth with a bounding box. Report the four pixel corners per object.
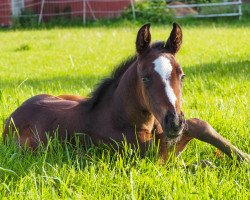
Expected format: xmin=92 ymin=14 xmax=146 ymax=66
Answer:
xmin=164 ymin=111 xmax=185 ymax=139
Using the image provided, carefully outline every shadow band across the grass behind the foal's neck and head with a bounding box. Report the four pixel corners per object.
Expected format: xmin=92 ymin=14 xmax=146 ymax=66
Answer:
xmin=0 ymin=60 xmax=250 ymax=91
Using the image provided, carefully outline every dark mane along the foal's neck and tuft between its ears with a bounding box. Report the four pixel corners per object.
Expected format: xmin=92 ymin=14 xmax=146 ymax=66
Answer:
xmin=85 ymin=42 xmax=165 ymax=109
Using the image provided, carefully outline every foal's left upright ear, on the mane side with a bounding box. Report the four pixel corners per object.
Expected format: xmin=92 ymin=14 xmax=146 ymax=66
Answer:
xmin=136 ymin=24 xmax=151 ymax=54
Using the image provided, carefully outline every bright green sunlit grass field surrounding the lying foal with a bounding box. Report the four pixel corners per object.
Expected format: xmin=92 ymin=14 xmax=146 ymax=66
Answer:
xmin=0 ymin=24 xmax=250 ymax=199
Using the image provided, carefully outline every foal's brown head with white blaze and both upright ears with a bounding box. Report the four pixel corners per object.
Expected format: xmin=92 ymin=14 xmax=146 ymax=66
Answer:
xmin=136 ymin=23 xmax=184 ymax=138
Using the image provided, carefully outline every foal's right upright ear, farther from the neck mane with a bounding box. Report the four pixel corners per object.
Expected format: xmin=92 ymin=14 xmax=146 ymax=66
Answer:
xmin=165 ymin=23 xmax=182 ymax=54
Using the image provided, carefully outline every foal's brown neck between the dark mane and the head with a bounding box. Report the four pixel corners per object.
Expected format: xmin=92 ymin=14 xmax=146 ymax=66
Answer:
xmin=112 ymin=61 xmax=149 ymax=125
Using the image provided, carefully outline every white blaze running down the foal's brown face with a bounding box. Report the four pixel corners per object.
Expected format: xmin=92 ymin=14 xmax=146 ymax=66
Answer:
xmin=153 ymin=56 xmax=176 ymax=108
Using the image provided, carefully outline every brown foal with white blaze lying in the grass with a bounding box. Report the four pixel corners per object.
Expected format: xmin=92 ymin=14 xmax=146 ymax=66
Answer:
xmin=3 ymin=23 xmax=250 ymax=161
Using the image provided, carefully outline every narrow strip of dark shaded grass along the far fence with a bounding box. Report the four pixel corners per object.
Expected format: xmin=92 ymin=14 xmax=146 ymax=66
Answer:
xmin=0 ymin=17 xmax=250 ymax=32
